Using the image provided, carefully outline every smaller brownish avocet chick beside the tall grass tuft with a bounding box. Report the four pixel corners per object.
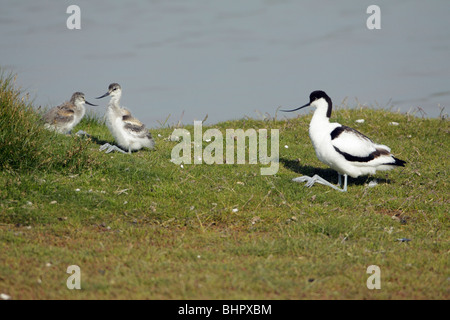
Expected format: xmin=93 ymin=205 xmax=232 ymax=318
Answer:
xmin=42 ymin=92 xmax=97 ymax=134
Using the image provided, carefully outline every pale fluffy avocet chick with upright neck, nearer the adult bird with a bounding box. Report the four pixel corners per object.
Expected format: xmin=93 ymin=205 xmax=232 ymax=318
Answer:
xmin=96 ymin=83 xmax=155 ymax=154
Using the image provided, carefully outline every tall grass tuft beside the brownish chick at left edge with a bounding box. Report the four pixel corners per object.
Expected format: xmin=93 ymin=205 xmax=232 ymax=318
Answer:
xmin=0 ymin=69 xmax=95 ymax=172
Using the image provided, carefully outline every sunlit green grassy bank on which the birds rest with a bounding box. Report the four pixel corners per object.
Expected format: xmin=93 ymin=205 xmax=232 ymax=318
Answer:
xmin=0 ymin=72 xmax=450 ymax=299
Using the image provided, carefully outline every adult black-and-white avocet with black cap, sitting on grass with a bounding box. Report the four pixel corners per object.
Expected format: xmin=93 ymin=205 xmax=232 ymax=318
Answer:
xmin=281 ymin=91 xmax=406 ymax=191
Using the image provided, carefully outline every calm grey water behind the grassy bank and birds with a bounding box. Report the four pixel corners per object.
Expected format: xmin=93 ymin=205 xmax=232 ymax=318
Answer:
xmin=0 ymin=0 xmax=450 ymax=127
